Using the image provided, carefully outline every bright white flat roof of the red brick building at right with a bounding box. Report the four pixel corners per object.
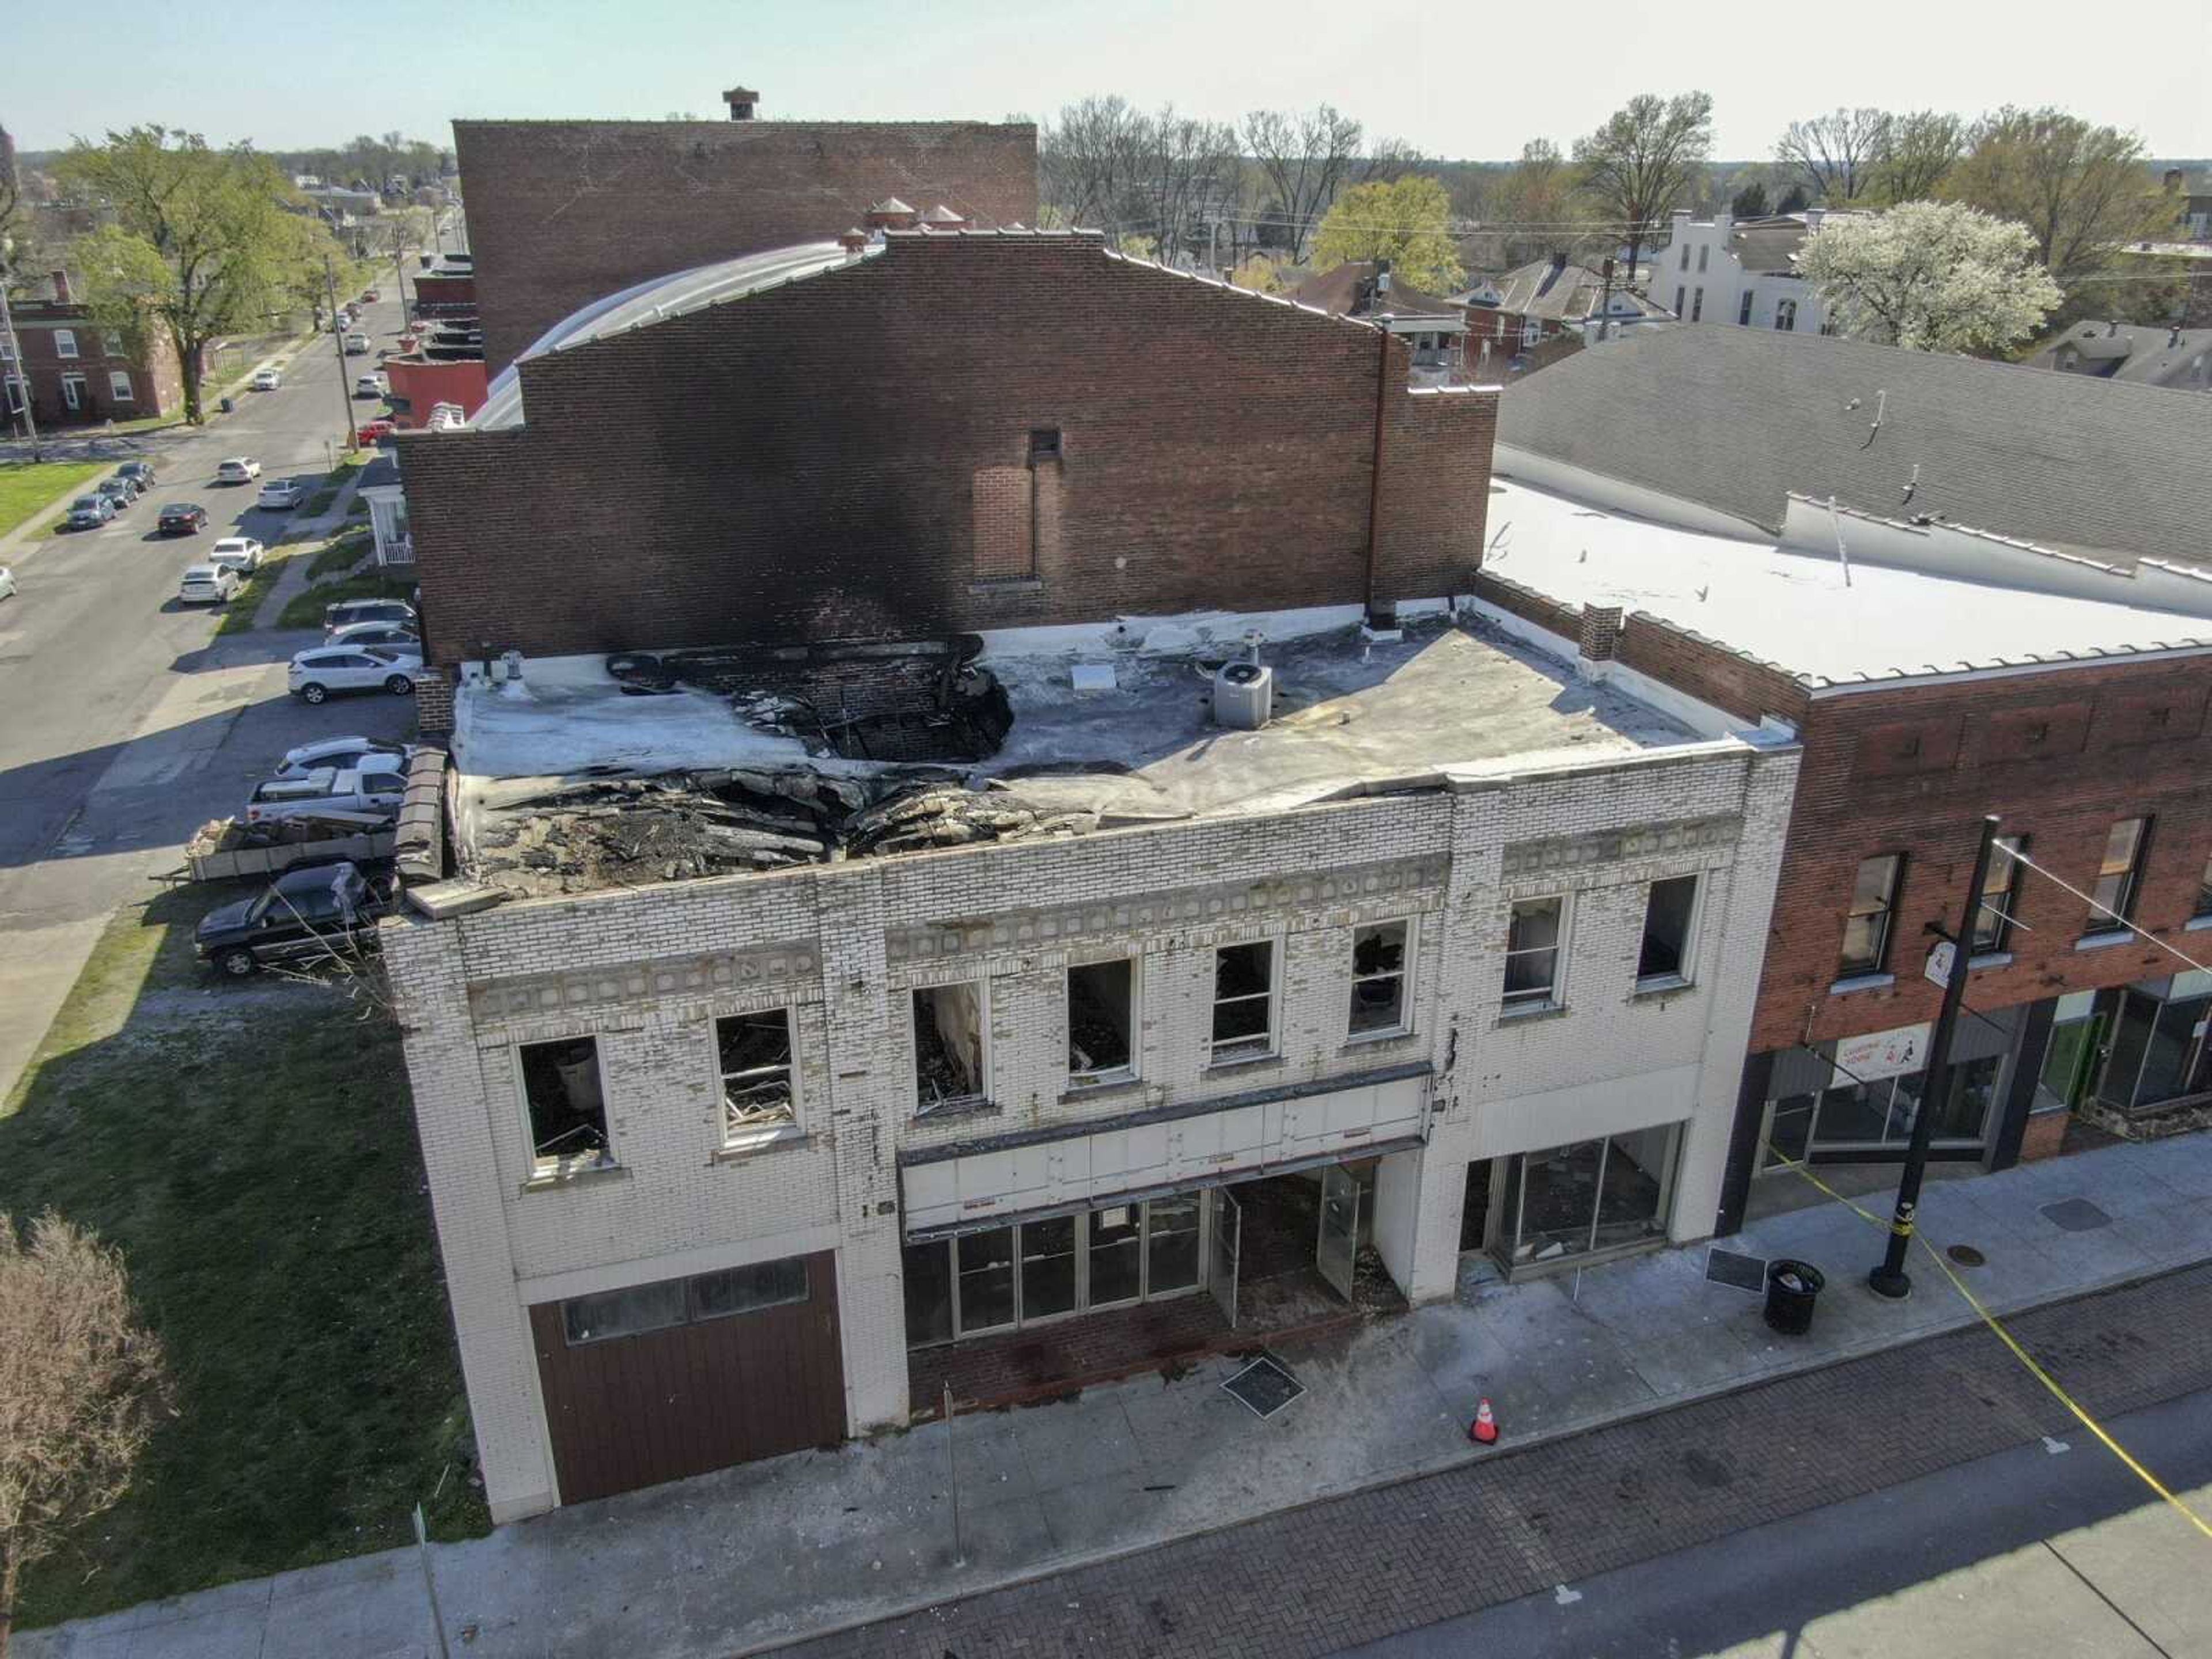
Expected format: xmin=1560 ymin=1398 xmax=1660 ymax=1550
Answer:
xmin=1482 ymin=482 xmax=2212 ymax=685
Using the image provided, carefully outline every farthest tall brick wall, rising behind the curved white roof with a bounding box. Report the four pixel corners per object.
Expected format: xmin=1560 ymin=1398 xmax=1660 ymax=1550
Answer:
xmin=453 ymin=122 xmax=1037 ymax=374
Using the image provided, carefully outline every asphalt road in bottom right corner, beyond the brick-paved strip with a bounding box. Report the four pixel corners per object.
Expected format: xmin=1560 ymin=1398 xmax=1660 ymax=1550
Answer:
xmin=1347 ymin=1391 xmax=2212 ymax=1659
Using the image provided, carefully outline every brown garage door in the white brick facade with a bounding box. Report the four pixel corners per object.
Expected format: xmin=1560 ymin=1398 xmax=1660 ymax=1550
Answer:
xmin=531 ymin=1252 xmax=845 ymax=1504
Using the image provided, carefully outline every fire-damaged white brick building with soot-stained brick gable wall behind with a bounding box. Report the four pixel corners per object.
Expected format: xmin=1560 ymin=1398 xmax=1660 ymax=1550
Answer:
xmin=385 ymin=218 xmax=1798 ymax=1520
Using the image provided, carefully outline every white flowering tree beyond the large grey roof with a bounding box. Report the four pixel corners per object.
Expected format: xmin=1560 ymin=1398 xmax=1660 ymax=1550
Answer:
xmin=1798 ymin=201 xmax=2064 ymax=352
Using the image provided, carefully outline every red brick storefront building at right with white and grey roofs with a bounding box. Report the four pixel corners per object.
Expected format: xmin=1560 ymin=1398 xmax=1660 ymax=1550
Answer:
xmin=1475 ymin=329 xmax=2212 ymax=1232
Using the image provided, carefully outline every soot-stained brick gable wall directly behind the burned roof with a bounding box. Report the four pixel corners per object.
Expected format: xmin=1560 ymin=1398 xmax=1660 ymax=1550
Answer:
xmin=398 ymin=234 xmax=1495 ymax=661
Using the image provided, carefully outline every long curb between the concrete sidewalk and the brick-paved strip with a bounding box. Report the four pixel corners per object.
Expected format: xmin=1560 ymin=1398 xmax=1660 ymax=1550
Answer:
xmin=728 ymin=1256 xmax=2212 ymax=1659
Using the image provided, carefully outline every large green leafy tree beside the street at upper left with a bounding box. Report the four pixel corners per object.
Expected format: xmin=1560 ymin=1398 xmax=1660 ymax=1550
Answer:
xmin=55 ymin=126 xmax=329 ymax=421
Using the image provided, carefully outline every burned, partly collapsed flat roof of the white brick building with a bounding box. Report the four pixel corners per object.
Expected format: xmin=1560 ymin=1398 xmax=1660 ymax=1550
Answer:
xmin=435 ymin=613 xmax=1701 ymax=893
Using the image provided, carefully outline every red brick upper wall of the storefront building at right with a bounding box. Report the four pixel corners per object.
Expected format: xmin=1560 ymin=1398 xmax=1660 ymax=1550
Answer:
xmin=1752 ymin=657 xmax=2212 ymax=1053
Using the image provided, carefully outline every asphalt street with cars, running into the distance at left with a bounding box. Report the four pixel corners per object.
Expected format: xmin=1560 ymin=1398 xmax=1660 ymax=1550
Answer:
xmin=0 ymin=294 xmax=411 ymax=1101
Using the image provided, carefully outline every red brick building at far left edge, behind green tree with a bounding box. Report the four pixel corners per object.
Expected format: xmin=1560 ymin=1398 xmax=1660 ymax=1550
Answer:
xmin=0 ymin=270 xmax=184 ymax=431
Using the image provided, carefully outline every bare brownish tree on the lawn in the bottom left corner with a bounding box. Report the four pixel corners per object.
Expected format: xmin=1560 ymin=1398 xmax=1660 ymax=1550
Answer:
xmin=0 ymin=1210 xmax=166 ymax=1659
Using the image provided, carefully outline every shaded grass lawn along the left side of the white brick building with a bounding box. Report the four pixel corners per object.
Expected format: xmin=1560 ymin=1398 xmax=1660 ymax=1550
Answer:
xmin=0 ymin=889 xmax=489 ymax=1626
